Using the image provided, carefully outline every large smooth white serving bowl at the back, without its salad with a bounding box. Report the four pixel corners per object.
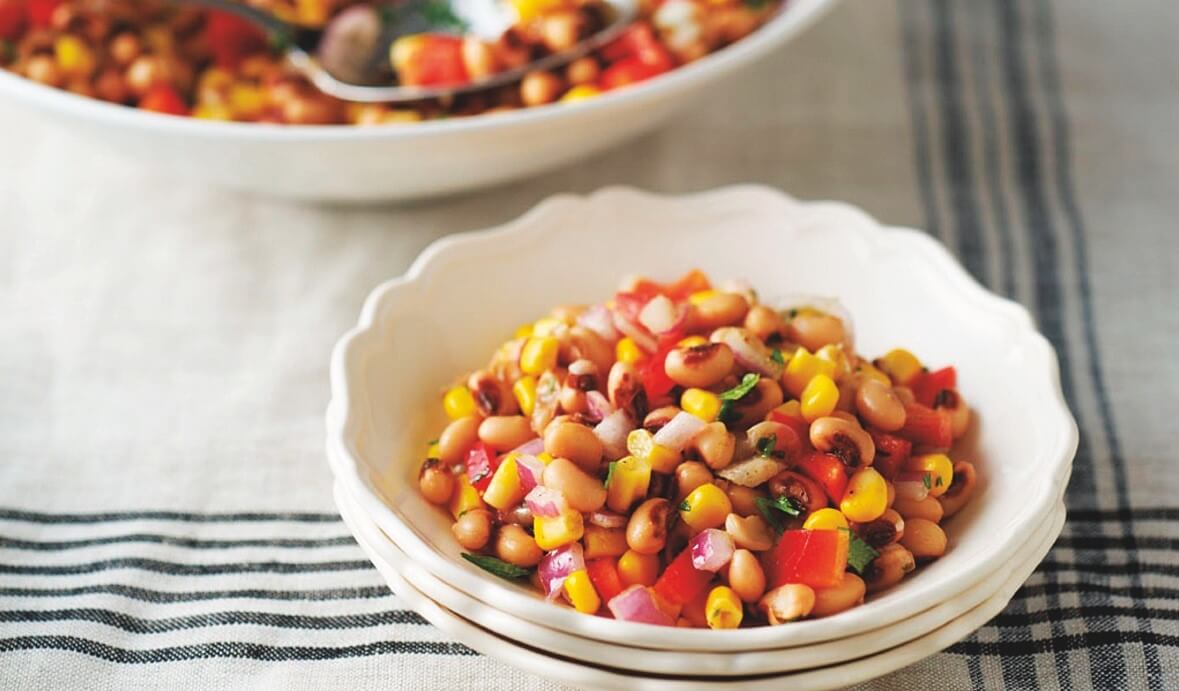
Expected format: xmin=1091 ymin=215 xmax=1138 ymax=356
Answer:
xmin=0 ymin=0 xmax=834 ymax=202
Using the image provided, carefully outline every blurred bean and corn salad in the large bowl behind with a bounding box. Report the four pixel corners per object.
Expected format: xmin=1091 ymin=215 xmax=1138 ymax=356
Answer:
xmin=0 ymin=0 xmax=778 ymax=125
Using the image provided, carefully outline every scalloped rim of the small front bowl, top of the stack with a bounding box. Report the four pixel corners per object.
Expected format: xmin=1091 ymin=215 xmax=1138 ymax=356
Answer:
xmin=327 ymin=185 xmax=1078 ymax=650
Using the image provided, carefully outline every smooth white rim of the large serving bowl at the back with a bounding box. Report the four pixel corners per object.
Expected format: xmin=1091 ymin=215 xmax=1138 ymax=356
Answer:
xmin=0 ymin=0 xmax=837 ymax=142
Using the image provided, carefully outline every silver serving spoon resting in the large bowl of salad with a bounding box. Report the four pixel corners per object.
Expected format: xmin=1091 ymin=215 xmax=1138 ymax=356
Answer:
xmin=172 ymin=0 xmax=638 ymax=103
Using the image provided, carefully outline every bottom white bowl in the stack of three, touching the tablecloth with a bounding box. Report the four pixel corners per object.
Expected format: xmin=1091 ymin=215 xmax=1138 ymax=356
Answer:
xmin=336 ymin=476 xmax=1065 ymax=691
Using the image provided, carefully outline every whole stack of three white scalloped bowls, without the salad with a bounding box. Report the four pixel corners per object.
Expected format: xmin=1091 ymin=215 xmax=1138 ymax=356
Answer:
xmin=328 ymin=186 xmax=1076 ymax=691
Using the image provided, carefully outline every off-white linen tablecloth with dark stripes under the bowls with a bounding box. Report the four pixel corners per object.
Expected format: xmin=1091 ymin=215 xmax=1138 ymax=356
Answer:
xmin=0 ymin=0 xmax=1179 ymax=690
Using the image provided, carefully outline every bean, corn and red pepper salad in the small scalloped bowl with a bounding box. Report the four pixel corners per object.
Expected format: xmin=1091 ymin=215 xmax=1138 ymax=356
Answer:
xmin=419 ymin=270 xmax=975 ymax=629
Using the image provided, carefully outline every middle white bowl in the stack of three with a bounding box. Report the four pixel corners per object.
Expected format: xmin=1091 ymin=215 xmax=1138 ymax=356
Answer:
xmin=335 ymin=462 xmax=1063 ymax=677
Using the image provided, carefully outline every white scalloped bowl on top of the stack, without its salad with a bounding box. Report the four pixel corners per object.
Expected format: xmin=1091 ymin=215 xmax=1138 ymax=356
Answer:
xmin=327 ymin=186 xmax=1078 ymax=651
